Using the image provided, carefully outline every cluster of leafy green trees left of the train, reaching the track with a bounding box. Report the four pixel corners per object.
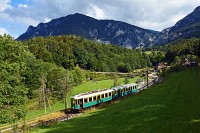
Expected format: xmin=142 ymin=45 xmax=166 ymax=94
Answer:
xmin=0 ymin=35 xmax=69 ymax=123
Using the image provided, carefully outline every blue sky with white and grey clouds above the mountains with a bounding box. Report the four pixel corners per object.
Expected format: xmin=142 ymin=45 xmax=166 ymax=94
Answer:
xmin=0 ymin=0 xmax=200 ymax=38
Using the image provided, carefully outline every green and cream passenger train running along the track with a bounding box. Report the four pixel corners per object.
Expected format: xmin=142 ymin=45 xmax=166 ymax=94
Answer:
xmin=71 ymin=76 xmax=158 ymax=111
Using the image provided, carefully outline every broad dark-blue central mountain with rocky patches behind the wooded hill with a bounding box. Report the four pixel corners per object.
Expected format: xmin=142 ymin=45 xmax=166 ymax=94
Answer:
xmin=17 ymin=13 xmax=159 ymax=48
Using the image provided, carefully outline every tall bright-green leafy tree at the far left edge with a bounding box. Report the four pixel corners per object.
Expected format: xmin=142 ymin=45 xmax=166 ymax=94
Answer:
xmin=0 ymin=35 xmax=30 ymax=123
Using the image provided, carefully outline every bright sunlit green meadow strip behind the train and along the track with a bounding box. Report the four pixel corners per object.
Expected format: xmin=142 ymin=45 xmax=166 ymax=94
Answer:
xmin=26 ymin=77 xmax=139 ymax=119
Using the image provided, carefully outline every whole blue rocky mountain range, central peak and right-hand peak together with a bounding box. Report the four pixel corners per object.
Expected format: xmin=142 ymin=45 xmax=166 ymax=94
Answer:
xmin=17 ymin=6 xmax=200 ymax=48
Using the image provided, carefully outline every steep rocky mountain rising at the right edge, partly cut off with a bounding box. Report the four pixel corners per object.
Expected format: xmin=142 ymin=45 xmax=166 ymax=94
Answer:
xmin=156 ymin=6 xmax=200 ymax=45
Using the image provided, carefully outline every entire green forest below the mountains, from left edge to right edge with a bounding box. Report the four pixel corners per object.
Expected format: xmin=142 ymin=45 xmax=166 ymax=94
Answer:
xmin=0 ymin=34 xmax=200 ymax=124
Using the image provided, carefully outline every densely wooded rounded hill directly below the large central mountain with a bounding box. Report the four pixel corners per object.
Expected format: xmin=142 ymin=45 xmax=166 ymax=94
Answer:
xmin=24 ymin=35 xmax=152 ymax=72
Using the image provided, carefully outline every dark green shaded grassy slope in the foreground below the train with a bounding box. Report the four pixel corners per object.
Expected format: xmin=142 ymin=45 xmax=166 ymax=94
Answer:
xmin=32 ymin=71 xmax=200 ymax=133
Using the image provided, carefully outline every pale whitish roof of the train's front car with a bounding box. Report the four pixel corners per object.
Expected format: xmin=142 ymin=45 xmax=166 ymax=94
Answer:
xmin=72 ymin=89 xmax=114 ymax=99
